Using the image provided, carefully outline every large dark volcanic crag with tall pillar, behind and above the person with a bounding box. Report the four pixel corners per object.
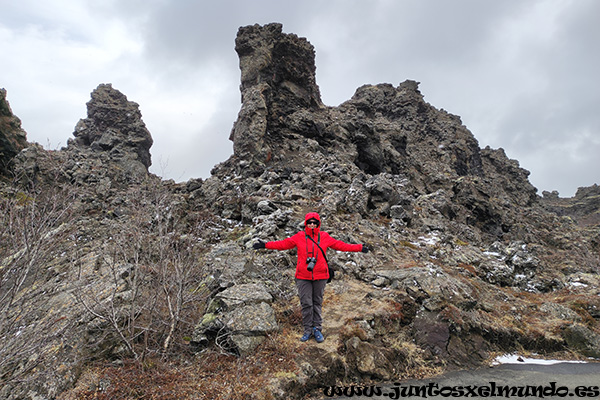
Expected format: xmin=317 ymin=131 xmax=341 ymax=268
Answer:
xmin=211 ymin=24 xmax=537 ymax=245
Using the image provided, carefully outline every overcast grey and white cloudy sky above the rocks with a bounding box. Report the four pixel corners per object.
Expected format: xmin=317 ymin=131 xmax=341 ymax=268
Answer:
xmin=0 ymin=0 xmax=600 ymax=197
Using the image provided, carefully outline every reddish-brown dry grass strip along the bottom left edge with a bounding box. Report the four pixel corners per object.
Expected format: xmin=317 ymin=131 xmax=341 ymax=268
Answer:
xmin=61 ymin=330 xmax=301 ymax=400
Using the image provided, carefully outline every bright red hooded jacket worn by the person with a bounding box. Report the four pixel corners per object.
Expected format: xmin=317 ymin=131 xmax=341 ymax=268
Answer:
xmin=265 ymin=212 xmax=363 ymax=280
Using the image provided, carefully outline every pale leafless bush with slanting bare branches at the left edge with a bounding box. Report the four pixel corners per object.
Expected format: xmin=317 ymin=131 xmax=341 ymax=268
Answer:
xmin=0 ymin=177 xmax=75 ymax=386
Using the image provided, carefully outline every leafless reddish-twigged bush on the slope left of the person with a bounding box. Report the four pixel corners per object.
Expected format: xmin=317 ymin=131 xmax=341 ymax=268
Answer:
xmin=78 ymin=179 xmax=208 ymax=359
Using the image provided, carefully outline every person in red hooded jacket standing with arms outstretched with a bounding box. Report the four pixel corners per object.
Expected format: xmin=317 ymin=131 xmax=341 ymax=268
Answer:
xmin=253 ymin=212 xmax=369 ymax=343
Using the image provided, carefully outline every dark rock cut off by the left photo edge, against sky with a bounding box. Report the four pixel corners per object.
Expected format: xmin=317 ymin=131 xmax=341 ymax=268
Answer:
xmin=0 ymin=89 xmax=27 ymax=176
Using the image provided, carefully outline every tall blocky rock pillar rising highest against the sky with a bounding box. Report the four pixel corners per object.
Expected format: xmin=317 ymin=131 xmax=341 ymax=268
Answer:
xmin=230 ymin=24 xmax=323 ymax=169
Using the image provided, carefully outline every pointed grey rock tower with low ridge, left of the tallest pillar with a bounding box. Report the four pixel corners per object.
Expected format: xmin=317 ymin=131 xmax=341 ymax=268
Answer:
xmin=14 ymin=84 xmax=153 ymax=195
